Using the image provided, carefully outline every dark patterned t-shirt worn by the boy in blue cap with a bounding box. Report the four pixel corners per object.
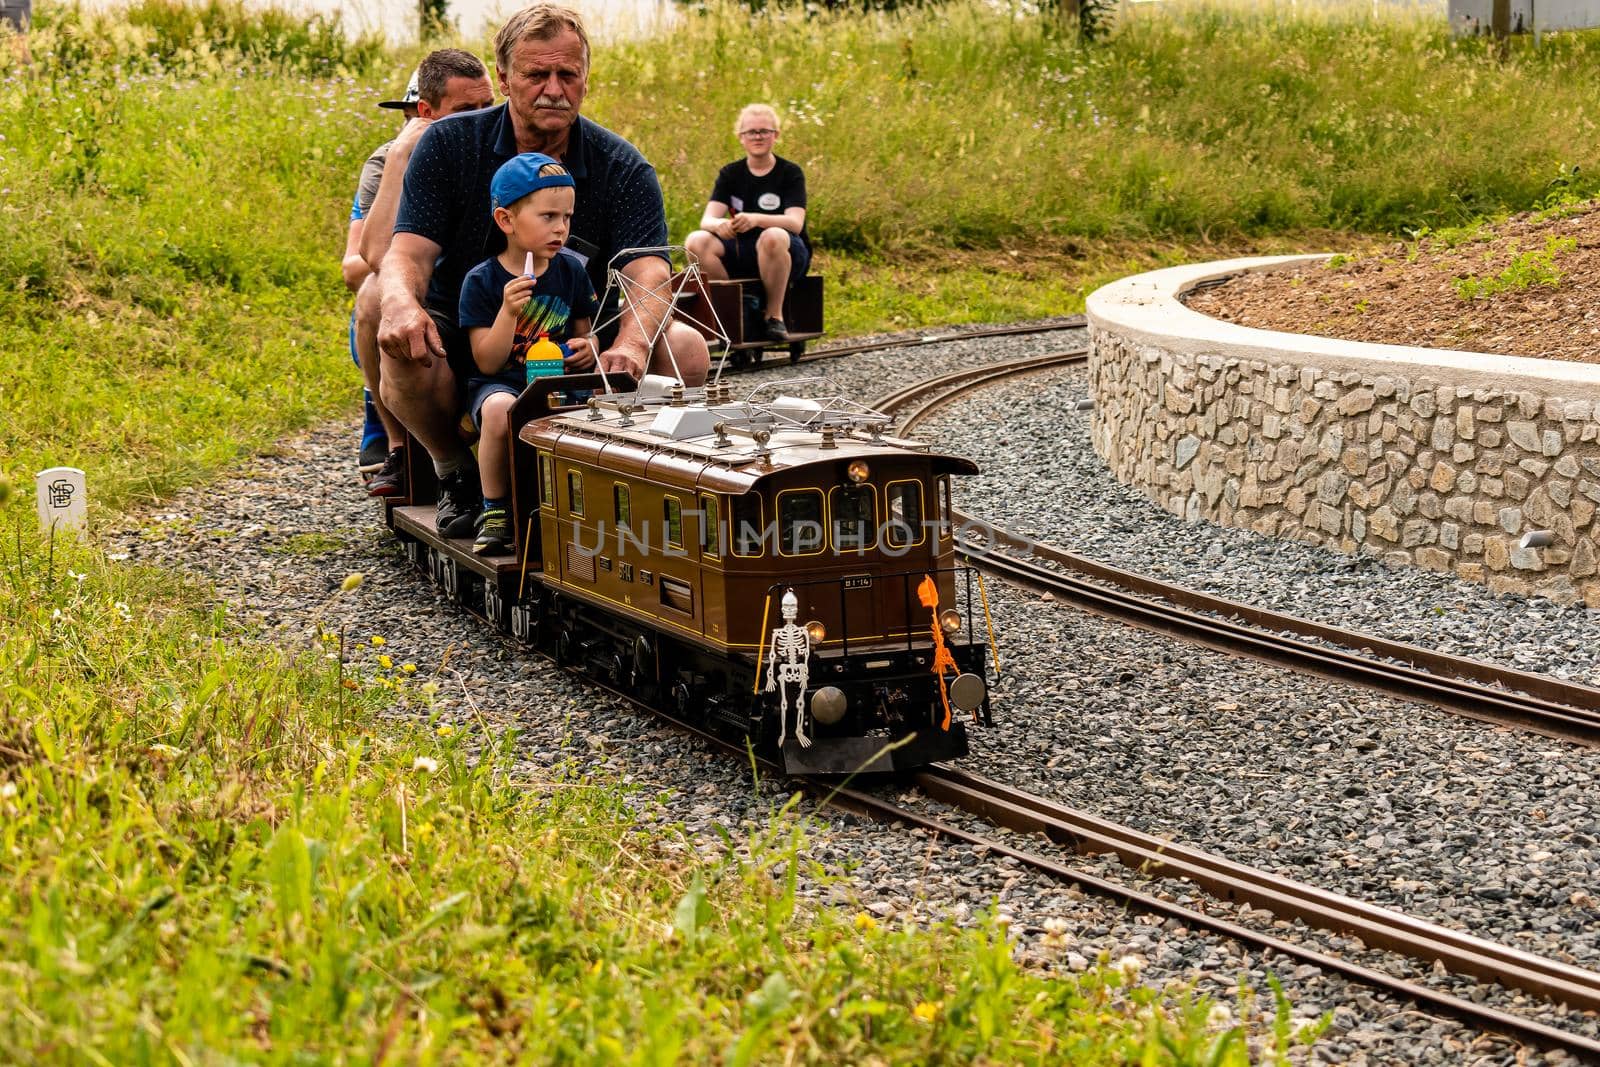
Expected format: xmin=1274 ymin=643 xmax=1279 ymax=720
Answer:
xmin=459 ymin=248 xmax=600 ymax=389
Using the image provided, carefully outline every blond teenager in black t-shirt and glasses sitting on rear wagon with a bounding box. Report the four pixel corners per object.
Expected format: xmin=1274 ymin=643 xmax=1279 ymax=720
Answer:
xmin=683 ymin=104 xmax=811 ymax=341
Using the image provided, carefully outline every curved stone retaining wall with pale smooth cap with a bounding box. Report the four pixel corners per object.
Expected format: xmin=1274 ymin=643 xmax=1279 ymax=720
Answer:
xmin=1088 ymin=256 xmax=1600 ymax=606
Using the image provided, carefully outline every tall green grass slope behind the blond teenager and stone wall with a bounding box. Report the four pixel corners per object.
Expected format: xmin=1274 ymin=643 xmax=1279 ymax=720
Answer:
xmin=592 ymin=3 xmax=1600 ymax=253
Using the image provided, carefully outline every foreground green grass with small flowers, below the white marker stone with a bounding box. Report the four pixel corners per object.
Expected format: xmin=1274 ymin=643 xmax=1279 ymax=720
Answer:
xmin=0 ymin=536 xmax=1315 ymax=1064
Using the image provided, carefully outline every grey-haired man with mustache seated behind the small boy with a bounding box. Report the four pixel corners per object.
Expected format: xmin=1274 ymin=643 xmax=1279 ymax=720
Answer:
xmin=378 ymin=3 xmax=710 ymax=537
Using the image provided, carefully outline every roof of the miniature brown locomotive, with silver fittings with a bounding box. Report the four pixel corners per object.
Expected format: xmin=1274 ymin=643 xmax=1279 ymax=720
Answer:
xmin=522 ymin=379 xmax=978 ymax=496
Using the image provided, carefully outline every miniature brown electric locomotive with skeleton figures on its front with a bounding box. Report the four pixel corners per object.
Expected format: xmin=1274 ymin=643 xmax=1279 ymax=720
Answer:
xmin=395 ymin=379 xmax=989 ymax=773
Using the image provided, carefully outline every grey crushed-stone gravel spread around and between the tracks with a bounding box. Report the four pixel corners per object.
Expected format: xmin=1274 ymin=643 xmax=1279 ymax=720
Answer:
xmin=114 ymin=323 xmax=1600 ymax=1064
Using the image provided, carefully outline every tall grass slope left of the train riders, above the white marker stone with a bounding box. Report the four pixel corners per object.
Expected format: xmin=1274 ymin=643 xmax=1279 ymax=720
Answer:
xmin=0 ymin=0 xmax=392 ymax=509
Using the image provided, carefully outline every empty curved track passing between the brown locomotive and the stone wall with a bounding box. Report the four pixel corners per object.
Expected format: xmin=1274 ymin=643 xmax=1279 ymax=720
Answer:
xmin=875 ymin=349 xmax=1600 ymax=747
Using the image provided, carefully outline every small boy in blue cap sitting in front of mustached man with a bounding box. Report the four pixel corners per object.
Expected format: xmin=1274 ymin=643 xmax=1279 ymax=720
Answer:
xmin=459 ymin=152 xmax=598 ymax=555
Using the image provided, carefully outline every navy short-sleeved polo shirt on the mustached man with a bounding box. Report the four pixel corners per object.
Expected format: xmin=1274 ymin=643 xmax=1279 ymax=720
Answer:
xmin=395 ymin=104 xmax=667 ymax=322
